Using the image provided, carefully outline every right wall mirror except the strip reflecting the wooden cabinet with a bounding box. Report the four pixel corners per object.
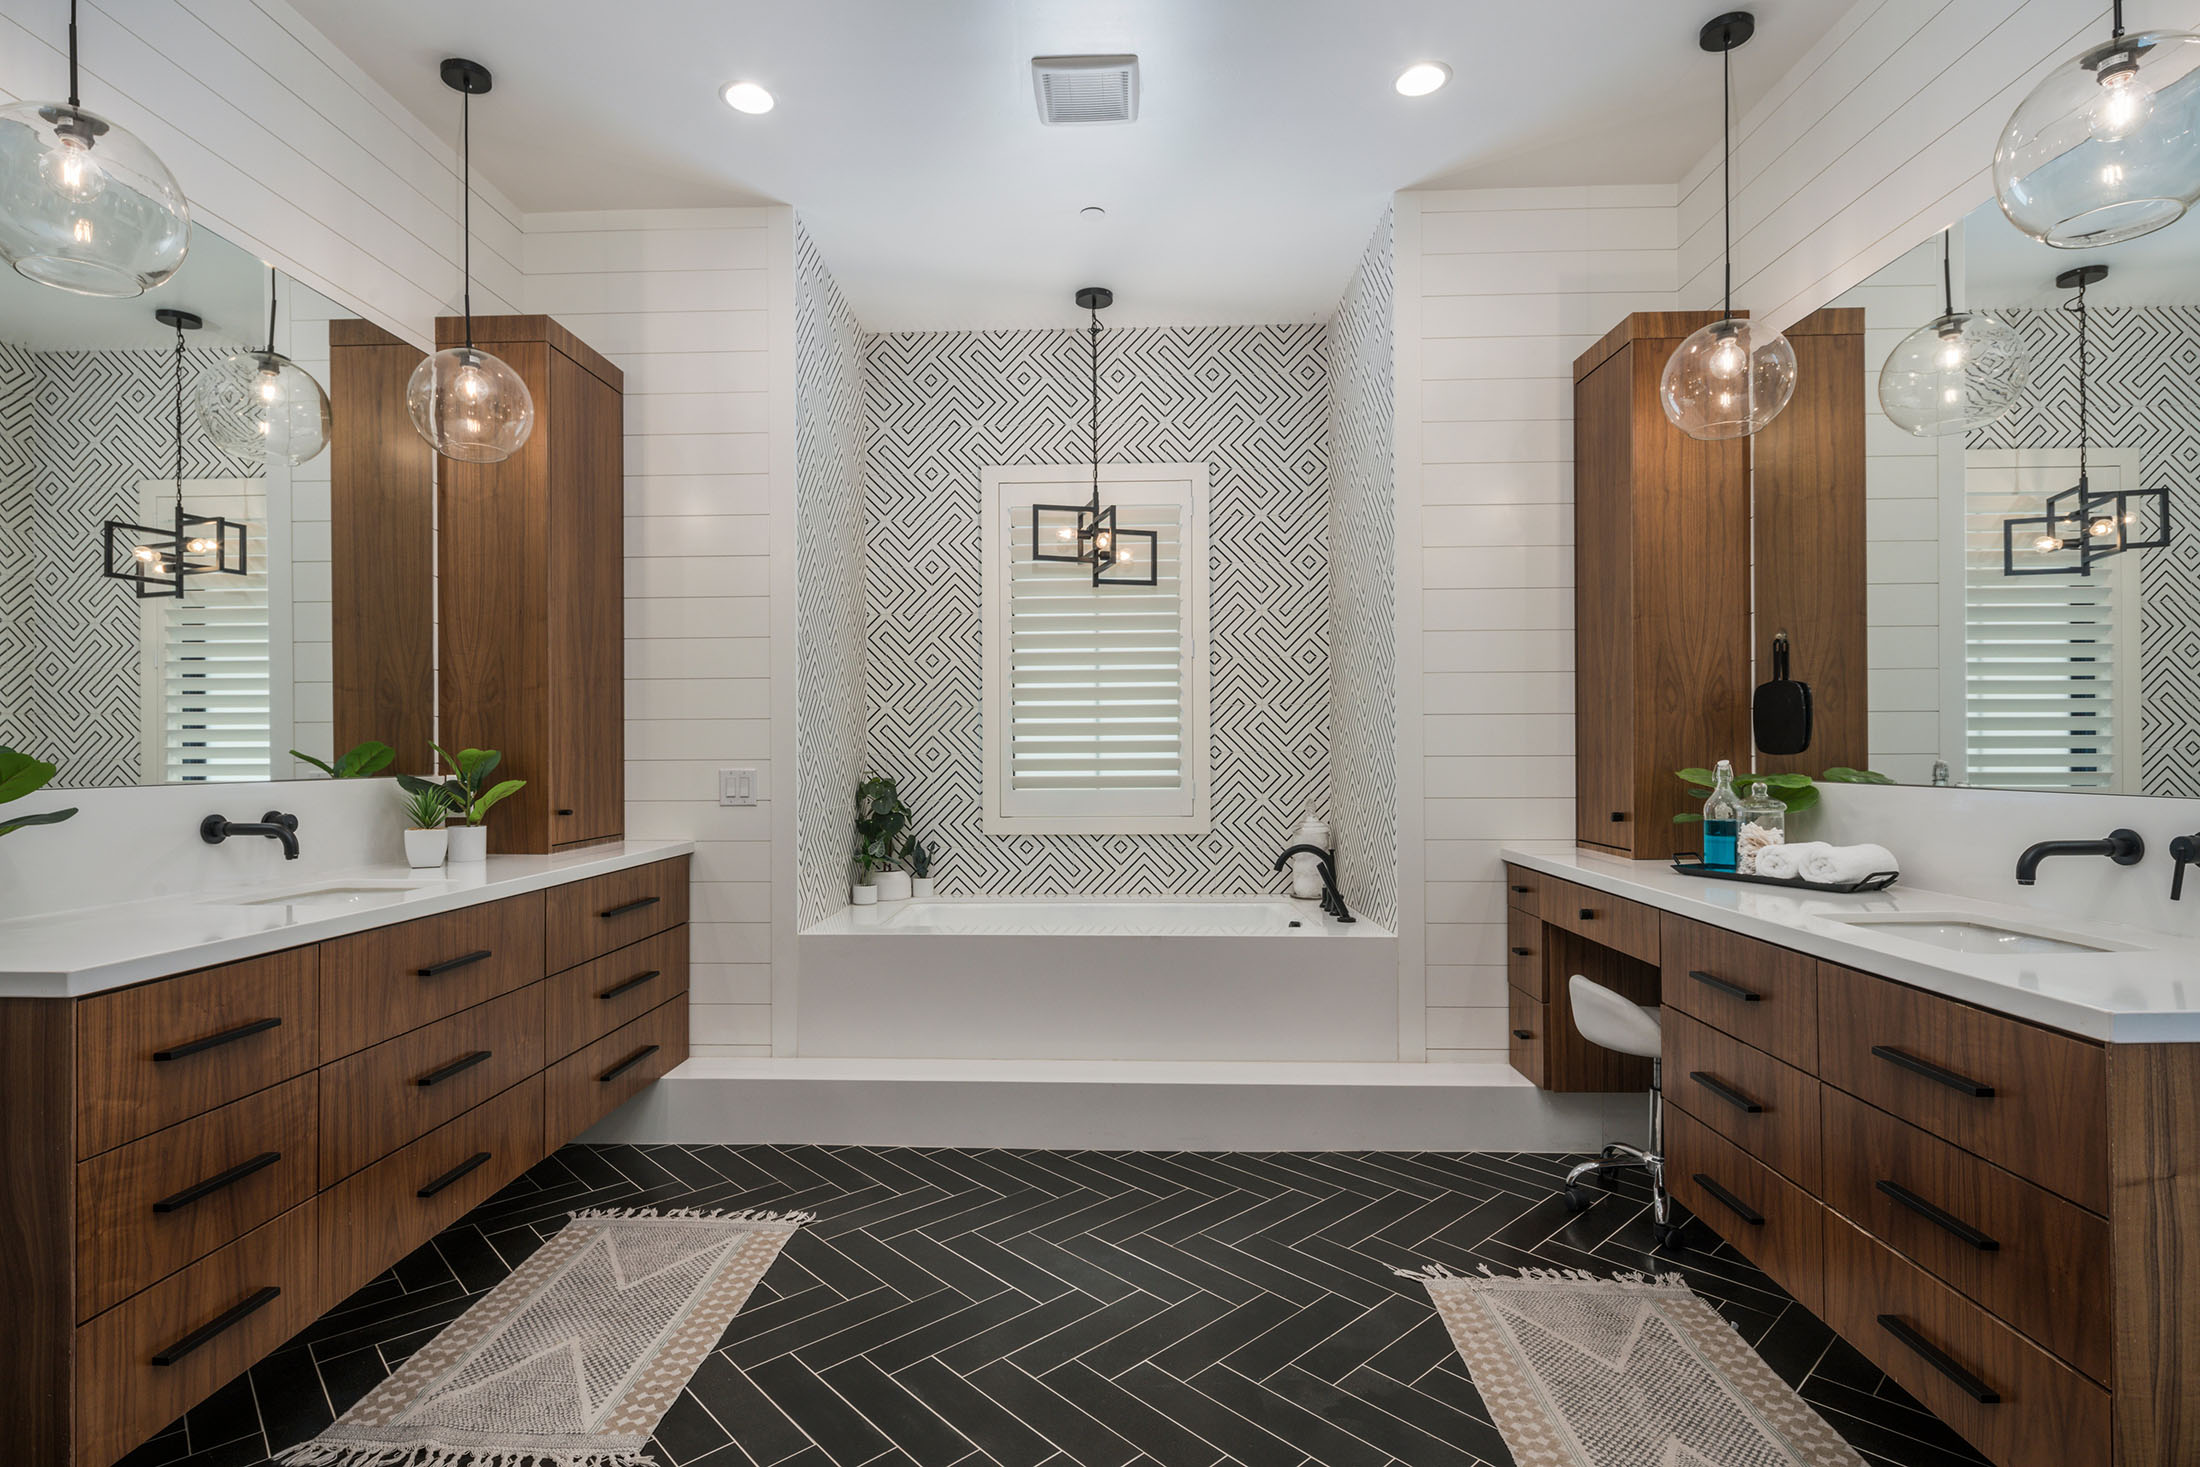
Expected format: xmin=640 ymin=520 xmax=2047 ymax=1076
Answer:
xmin=1833 ymin=200 xmax=2200 ymax=796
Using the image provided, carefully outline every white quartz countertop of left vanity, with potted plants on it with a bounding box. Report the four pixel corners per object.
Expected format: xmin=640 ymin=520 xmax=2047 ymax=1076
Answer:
xmin=0 ymin=840 xmax=695 ymax=999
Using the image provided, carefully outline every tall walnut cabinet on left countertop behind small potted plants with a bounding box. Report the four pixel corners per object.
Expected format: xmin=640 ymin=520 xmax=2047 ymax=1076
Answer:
xmin=436 ymin=317 xmax=627 ymax=851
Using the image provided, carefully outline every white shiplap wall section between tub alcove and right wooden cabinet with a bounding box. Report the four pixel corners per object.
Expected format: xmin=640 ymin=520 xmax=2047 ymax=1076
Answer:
xmin=1397 ymin=185 xmax=1676 ymax=1062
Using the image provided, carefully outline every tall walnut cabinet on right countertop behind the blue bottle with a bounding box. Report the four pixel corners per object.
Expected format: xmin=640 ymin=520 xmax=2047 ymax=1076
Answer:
xmin=1573 ymin=310 xmax=1749 ymax=860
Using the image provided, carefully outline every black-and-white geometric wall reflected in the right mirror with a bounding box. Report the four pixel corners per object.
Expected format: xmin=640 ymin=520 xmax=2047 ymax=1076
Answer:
xmin=1965 ymin=306 xmax=2200 ymax=796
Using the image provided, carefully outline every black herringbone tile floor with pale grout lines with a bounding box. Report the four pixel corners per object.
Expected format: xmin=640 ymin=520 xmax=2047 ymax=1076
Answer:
xmin=123 ymin=1146 xmax=2006 ymax=1467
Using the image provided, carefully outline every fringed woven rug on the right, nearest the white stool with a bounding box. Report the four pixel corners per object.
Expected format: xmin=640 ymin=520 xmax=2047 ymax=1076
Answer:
xmin=1399 ymin=1265 xmax=1863 ymax=1467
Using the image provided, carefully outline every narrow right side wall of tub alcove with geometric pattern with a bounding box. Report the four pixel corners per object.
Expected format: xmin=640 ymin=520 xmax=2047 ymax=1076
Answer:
xmin=1329 ymin=209 xmax=1397 ymax=933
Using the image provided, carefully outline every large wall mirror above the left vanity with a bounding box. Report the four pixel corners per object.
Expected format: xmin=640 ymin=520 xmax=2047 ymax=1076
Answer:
xmin=0 ymin=224 xmax=433 ymax=787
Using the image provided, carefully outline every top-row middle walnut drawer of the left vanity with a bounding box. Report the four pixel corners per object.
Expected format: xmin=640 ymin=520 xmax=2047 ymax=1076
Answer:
xmin=321 ymin=891 xmax=543 ymax=1062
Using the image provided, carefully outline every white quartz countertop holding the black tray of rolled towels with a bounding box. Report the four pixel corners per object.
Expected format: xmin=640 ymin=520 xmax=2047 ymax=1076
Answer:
xmin=1503 ymin=842 xmax=2200 ymax=1045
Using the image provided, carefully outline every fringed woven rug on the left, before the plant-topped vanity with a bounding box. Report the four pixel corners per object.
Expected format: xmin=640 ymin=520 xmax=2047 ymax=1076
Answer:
xmin=277 ymin=1210 xmax=810 ymax=1467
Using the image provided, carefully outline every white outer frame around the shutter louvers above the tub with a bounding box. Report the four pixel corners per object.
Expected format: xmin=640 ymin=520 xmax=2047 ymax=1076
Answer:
xmin=979 ymin=462 xmax=1212 ymax=836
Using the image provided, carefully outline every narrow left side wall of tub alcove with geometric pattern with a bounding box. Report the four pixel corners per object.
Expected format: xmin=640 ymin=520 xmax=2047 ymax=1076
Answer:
xmin=794 ymin=220 xmax=865 ymax=926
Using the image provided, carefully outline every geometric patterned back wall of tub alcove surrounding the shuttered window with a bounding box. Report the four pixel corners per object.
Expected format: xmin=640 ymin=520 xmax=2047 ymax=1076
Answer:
xmin=862 ymin=326 xmax=1329 ymax=895
